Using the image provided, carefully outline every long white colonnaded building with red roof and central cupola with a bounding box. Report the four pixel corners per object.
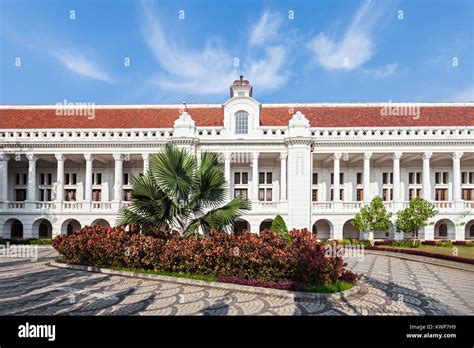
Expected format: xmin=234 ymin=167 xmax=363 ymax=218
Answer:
xmin=0 ymin=77 xmax=474 ymax=240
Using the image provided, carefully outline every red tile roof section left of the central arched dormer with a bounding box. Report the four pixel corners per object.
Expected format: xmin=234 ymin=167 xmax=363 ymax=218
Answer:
xmin=0 ymin=108 xmax=224 ymax=129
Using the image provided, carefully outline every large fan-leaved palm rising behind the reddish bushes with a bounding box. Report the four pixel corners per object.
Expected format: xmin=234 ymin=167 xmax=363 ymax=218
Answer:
xmin=118 ymin=144 xmax=250 ymax=235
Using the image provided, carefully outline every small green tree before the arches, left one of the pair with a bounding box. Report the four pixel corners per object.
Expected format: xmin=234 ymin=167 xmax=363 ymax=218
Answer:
xmin=352 ymin=196 xmax=392 ymax=242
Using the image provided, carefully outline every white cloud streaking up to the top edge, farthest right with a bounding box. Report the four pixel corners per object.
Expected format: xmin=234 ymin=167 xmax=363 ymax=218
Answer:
xmin=307 ymin=1 xmax=392 ymax=70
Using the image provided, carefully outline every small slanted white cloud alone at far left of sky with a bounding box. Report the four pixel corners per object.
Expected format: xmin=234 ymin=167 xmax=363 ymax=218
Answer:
xmin=51 ymin=51 xmax=111 ymax=82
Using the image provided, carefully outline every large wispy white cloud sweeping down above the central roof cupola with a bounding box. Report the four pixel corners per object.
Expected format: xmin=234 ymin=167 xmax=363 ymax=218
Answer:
xmin=142 ymin=2 xmax=287 ymax=94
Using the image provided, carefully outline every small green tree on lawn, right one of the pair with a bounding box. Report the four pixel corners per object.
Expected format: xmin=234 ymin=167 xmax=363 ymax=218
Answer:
xmin=396 ymin=197 xmax=438 ymax=246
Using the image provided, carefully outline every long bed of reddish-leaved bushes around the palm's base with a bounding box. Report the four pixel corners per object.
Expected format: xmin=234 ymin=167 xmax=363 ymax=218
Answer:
xmin=53 ymin=226 xmax=357 ymax=288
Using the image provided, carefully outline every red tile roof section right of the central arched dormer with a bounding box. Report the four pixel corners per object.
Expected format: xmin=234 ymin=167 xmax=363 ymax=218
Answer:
xmin=260 ymin=106 xmax=474 ymax=128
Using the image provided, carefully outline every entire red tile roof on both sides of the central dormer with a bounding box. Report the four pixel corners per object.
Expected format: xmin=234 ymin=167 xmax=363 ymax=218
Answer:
xmin=0 ymin=105 xmax=474 ymax=129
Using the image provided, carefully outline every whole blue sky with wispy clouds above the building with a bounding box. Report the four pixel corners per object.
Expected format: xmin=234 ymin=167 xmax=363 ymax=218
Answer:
xmin=0 ymin=0 xmax=474 ymax=104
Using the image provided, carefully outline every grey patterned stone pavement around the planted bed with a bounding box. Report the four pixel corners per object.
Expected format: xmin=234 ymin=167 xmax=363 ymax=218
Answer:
xmin=0 ymin=248 xmax=474 ymax=315
